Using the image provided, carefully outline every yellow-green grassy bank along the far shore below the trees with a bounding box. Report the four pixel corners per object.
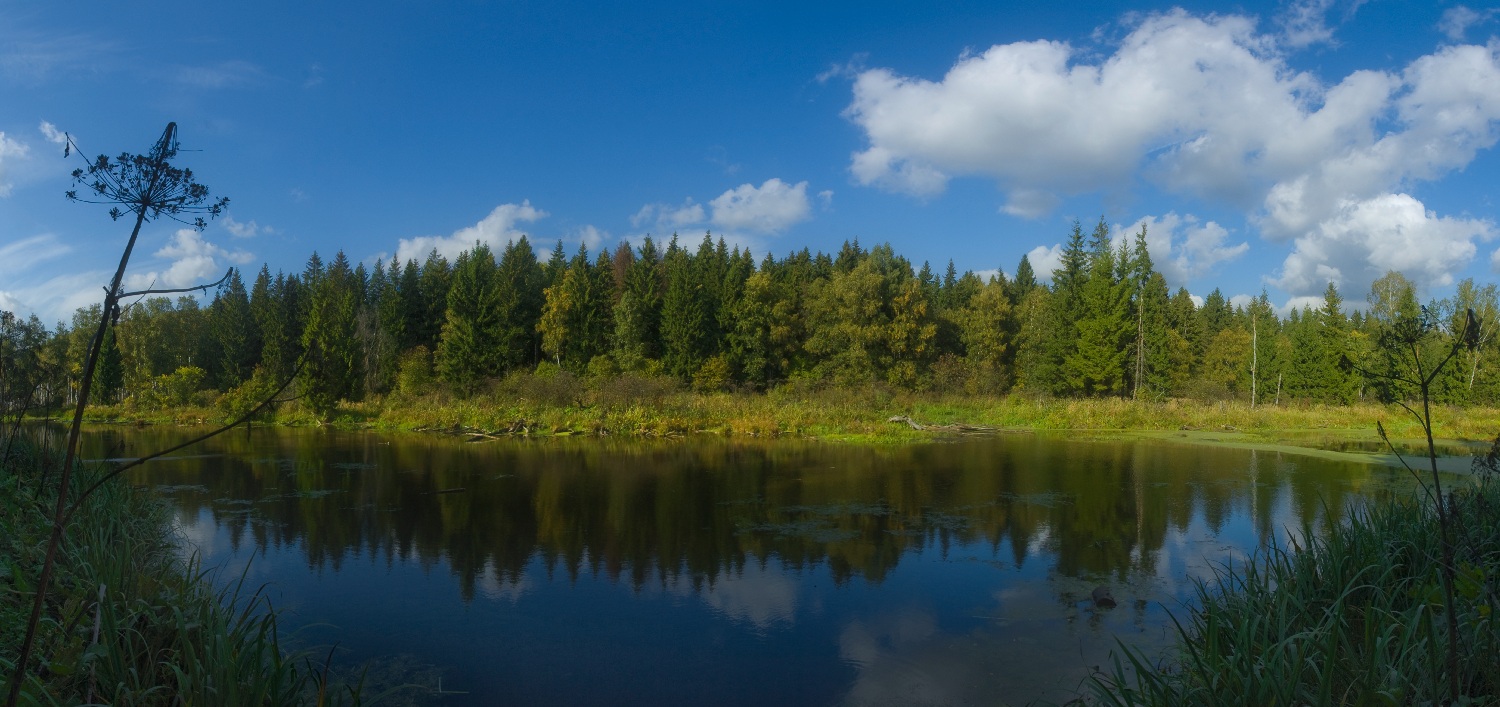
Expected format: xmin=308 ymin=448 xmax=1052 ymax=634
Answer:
xmin=76 ymin=374 xmax=1500 ymax=443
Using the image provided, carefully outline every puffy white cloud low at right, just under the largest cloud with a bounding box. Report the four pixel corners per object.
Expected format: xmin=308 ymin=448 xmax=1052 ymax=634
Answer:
xmin=1275 ymin=194 xmax=1497 ymax=300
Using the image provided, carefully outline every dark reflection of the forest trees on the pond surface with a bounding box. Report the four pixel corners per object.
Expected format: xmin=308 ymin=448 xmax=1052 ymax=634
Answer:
xmin=93 ymin=429 xmax=1368 ymax=597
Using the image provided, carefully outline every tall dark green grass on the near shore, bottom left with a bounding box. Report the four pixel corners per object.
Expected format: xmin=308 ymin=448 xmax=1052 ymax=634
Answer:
xmin=0 ymin=437 xmax=387 ymax=705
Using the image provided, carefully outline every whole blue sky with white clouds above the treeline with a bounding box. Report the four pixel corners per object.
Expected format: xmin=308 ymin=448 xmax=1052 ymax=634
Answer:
xmin=0 ymin=0 xmax=1500 ymax=321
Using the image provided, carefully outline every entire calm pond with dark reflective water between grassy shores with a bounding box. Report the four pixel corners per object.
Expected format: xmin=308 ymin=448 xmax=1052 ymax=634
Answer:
xmin=79 ymin=429 xmax=1403 ymax=705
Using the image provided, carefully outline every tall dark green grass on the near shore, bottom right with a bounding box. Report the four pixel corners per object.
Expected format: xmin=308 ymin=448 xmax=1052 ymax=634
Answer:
xmin=1092 ymin=482 xmax=1500 ymax=705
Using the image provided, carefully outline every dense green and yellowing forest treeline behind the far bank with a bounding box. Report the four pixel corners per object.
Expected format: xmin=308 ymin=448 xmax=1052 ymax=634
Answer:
xmin=0 ymin=221 xmax=1500 ymax=414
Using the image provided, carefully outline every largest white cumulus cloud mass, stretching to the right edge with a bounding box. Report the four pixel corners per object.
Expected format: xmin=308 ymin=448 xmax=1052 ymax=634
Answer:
xmin=845 ymin=11 xmax=1500 ymax=296
